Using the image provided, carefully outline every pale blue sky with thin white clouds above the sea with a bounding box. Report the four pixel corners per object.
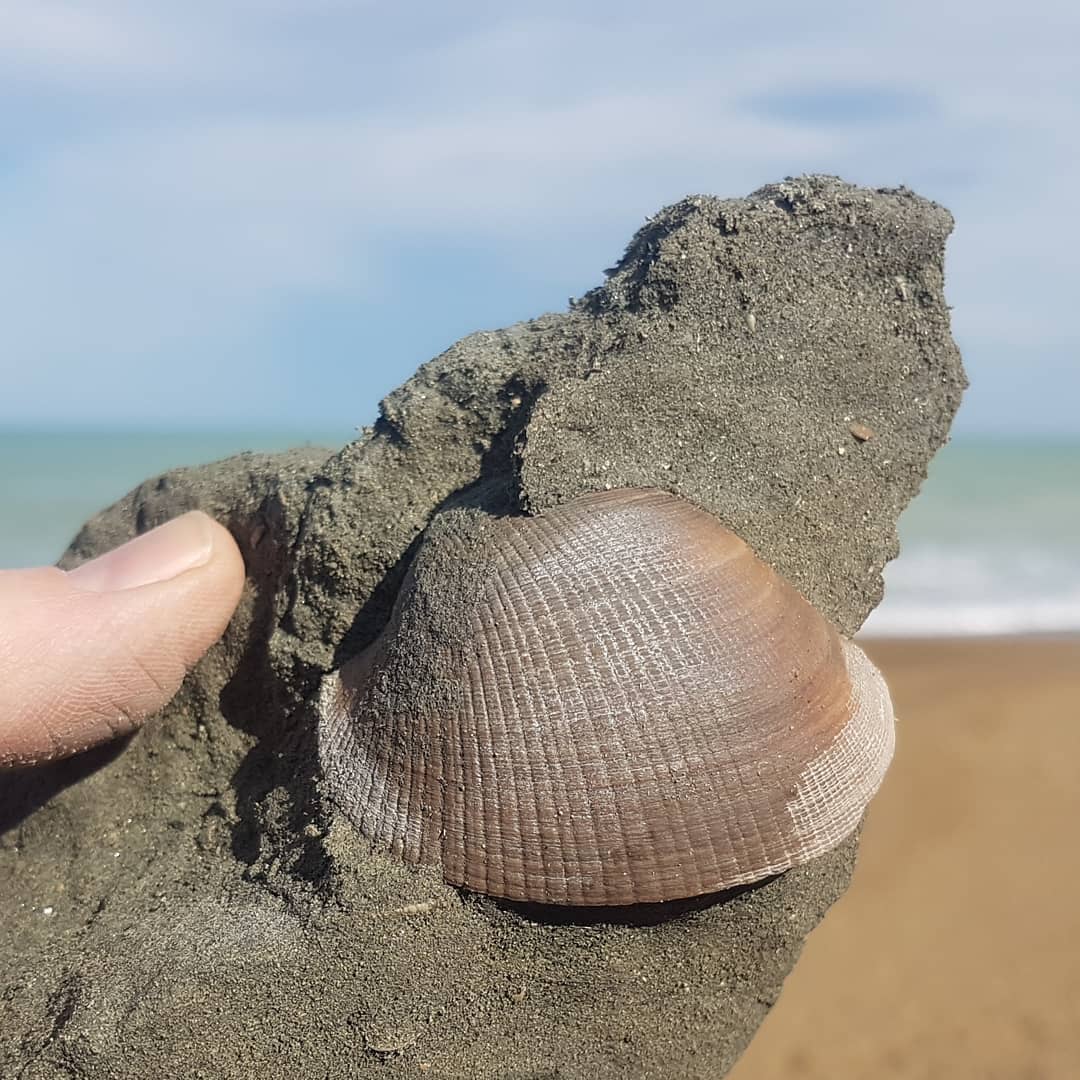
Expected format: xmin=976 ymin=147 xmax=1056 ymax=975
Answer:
xmin=0 ymin=0 xmax=1080 ymax=434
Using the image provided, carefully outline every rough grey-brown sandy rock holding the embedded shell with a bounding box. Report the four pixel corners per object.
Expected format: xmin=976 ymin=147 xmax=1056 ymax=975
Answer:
xmin=0 ymin=177 xmax=964 ymax=1080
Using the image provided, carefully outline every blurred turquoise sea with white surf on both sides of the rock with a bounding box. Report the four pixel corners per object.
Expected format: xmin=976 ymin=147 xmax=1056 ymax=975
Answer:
xmin=0 ymin=428 xmax=1080 ymax=637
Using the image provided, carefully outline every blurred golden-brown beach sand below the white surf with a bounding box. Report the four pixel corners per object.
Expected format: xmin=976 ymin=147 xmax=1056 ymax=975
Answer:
xmin=730 ymin=638 xmax=1080 ymax=1080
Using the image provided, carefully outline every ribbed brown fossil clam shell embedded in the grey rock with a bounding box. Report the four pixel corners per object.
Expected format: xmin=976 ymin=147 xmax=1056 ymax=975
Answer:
xmin=319 ymin=489 xmax=893 ymax=905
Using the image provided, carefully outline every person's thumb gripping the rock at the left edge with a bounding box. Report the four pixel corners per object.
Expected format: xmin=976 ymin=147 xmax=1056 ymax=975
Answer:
xmin=0 ymin=511 xmax=244 ymax=767
